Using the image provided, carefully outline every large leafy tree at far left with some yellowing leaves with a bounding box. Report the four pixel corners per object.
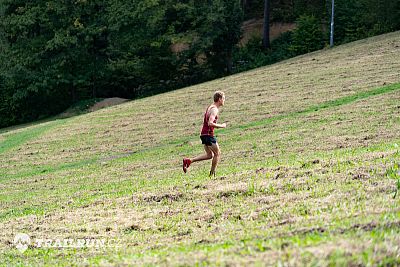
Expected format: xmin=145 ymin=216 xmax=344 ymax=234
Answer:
xmin=0 ymin=0 xmax=107 ymax=122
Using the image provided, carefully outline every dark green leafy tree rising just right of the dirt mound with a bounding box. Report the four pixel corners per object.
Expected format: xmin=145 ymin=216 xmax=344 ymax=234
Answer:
xmin=106 ymin=0 xmax=176 ymax=98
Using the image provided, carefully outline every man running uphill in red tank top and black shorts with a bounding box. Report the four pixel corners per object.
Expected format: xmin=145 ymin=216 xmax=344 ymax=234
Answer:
xmin=182 ymin=91 xmax=226 ymax=176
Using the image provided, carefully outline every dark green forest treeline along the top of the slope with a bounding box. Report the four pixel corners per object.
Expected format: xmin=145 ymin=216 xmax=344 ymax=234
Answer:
xmin=0 ymin=0 xmax=400 ymax=127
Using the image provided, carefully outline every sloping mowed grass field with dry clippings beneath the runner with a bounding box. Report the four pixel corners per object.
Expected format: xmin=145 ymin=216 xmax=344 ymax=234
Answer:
xmin=0 ymin=32 xmax=400 ymax=266
